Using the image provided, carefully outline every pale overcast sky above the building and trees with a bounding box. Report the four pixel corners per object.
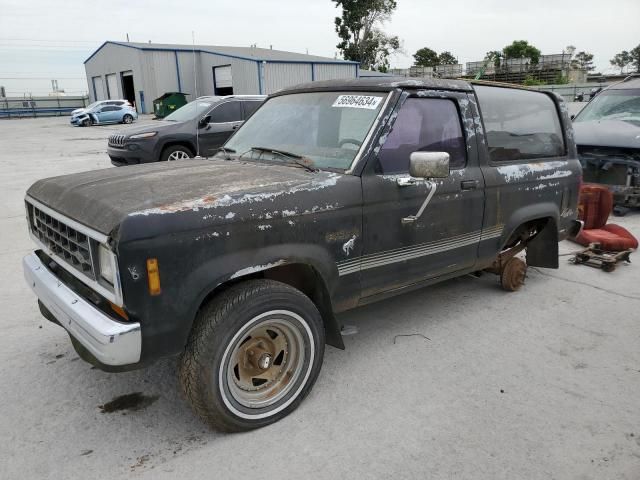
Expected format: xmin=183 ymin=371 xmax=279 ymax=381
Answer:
xmin=0 ymin=0 xmax=640 ymax=95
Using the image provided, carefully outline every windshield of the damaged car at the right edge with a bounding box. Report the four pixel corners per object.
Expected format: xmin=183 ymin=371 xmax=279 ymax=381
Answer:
xmin=575 ymin=88 xmax=640 ymax=122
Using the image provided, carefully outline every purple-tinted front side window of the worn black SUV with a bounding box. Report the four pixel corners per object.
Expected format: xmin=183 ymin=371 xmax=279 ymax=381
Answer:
xmin=378 ymin=98 xmax=467 ymax=173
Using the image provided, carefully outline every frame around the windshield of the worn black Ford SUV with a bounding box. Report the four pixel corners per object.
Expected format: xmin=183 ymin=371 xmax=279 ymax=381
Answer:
xmin=219 ymin=88 xmax=396 ymax=174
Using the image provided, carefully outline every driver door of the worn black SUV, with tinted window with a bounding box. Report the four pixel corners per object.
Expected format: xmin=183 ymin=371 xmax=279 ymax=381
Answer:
xmin=360 ymin=90 xmax=484 ymax=303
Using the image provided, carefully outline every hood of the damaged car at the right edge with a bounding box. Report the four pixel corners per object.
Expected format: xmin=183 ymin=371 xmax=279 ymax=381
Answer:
xmin=573 ymin=120 xmax=640 ymax=148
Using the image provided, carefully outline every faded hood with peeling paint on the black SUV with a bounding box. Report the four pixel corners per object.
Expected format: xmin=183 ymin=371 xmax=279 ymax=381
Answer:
xmin=27 ymin=160 xmax=344 ymax=237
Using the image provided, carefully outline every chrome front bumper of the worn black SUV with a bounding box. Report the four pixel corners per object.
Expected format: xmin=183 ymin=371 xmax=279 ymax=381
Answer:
xmin=22 ymin=253 xmax=142 ymax=366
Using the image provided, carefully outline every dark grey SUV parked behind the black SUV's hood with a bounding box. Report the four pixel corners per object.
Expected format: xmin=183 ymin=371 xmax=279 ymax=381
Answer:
xmin=107 ymin=95 xmax=266 ymax=167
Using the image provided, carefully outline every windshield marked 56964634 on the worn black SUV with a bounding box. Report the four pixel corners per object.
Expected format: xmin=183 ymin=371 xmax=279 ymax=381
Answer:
xmin=223 ymin=92 xmax=386 ymax=170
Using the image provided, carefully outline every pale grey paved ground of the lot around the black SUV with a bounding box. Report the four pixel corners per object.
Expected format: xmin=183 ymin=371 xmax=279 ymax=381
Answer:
xmin=0 ymin=117 xmax=640 ymax=480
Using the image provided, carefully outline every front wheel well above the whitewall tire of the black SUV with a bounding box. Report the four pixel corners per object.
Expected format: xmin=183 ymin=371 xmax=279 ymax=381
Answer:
xmin=199 ymin=263 xmax=344 ymax=349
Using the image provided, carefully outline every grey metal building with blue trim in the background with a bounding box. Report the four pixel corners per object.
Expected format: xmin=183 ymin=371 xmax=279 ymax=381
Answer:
xmin=84 ymin=41 xmax=358 ymax=113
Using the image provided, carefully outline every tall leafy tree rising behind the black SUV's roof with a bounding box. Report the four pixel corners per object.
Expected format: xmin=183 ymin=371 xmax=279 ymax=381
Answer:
xmin=333 ymin=0 xmax=400 ymax=71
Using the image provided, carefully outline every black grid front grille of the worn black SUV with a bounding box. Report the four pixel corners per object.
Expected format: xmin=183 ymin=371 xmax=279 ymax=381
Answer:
xmin=31 ymin=205 xmax=96 ymax=280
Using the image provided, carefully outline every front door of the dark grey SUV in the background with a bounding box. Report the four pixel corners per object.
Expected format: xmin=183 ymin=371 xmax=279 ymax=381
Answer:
xmin=198 ymin=100 xmax=242 ymax=157
